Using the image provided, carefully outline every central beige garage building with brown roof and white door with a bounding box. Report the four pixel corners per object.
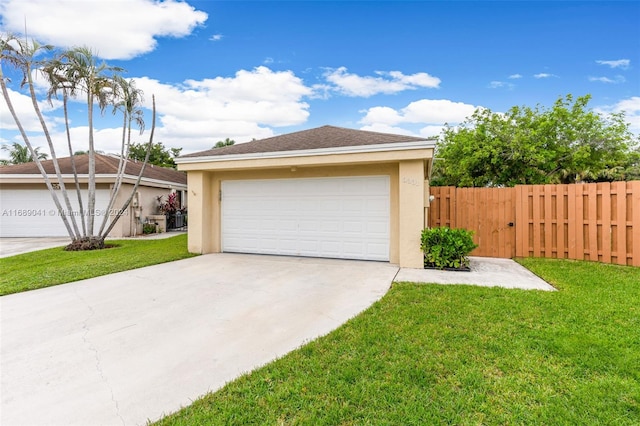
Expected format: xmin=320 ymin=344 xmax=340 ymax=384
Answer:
xmin=176 ymin=126 xmax=435 ymax=268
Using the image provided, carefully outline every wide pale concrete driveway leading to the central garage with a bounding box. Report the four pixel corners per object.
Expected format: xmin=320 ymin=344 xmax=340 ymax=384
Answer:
xmin=0 ymin=254 xmax=398 ymax=426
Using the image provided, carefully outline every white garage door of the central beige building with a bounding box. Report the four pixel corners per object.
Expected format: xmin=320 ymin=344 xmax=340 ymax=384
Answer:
xmin=222 ymin=176 xmax=389 ymax=261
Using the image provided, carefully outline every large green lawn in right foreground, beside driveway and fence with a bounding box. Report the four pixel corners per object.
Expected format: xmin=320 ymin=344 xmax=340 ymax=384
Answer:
xmin=158 ymin=259 xmax=640 ymax=425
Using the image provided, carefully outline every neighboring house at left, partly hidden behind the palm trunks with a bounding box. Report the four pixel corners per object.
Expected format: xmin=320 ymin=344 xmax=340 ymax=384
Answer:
xmin=0 ymin=154 xmax=187 ymax=237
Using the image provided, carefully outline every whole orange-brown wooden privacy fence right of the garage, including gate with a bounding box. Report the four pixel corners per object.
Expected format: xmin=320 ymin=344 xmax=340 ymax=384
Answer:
xmin=429 ymin=181 xmax=640 ymax=266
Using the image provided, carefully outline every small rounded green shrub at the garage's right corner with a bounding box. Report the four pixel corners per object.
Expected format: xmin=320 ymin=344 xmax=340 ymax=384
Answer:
xmin=420 ymin=227 xmax=478 ymax=269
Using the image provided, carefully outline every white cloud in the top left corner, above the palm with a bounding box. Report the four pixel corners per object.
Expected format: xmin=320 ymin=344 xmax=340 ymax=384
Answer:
xmin=0 ymin=0 xmax=207 ymax=59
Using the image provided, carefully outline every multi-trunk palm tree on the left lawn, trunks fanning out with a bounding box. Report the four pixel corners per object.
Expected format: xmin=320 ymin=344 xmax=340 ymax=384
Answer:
xmin=0 ymin=35 xmax=156 ymax=250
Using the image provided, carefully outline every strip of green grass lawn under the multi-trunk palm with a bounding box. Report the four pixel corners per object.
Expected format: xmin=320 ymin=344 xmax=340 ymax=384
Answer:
xmin=0 ymin=234 xmax=195 ymax=295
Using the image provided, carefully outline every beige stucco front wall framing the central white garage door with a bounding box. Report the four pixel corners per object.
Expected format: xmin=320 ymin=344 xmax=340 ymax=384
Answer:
xmin=184 ymin=149 xmax=433 ymax=268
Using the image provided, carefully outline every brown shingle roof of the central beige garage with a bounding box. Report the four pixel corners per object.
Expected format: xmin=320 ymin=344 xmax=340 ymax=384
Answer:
xmin=182 ymin=126 xmax=436 ymax=158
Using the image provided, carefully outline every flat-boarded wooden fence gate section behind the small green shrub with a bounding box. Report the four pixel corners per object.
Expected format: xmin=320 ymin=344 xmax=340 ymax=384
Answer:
xmin=429 ymin=187 xmax=516 ymax=258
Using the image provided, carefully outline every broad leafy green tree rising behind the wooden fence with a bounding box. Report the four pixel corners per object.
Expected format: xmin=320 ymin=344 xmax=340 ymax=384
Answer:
xmin=432 ymin=95 xmax=638 ymax=187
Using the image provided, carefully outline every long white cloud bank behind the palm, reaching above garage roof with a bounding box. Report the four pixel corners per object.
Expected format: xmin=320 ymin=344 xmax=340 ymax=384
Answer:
xmin=0 ymin=67 xmax=312 ymax=155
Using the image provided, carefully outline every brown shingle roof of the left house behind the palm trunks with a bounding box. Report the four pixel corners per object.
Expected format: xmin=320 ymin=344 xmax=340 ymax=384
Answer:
xmin=0 ymin=154 xmax=187 ymax=185
